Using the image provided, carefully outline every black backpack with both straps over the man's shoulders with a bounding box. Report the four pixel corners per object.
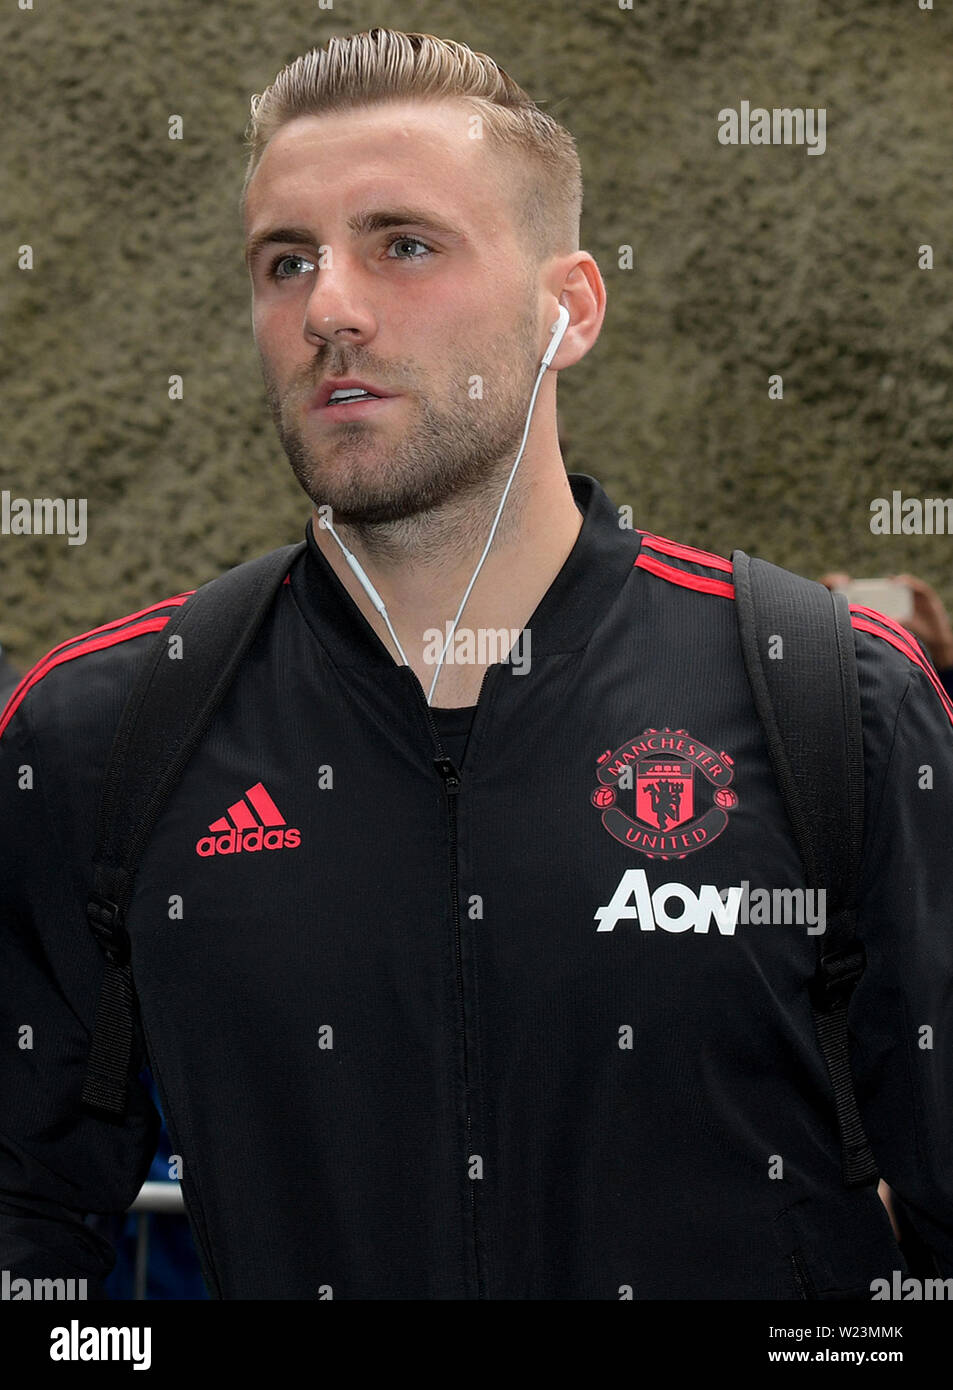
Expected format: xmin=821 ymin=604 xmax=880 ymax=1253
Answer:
xmin=82 ymin=542 xmax=878 ymax=1187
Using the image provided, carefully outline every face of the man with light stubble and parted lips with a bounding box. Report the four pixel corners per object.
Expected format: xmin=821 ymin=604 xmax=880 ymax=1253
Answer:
xmin=245 ymin=101 xmax=543 ymax=524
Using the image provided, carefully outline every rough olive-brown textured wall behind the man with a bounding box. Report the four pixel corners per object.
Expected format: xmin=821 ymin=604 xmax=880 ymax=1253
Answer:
xmin=0 ymin=0 xmax=953 ymax=669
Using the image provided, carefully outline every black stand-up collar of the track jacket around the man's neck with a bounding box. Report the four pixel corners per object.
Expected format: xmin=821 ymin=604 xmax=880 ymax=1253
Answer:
xmin=290 ymin=473 xmax=640 ymax=669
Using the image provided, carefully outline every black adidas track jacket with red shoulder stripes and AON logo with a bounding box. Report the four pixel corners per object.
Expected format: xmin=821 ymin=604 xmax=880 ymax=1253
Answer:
xmin=0 ymin=474 xmax=953 ymax=1300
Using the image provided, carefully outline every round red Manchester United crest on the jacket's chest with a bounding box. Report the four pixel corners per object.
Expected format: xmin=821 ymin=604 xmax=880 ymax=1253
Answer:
xmin=592 ymin=728 xmax=738 ymax=859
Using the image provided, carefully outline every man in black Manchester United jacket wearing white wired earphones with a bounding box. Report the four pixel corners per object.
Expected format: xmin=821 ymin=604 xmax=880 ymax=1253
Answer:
xmin=0 ymin=29 xmax=953 ymax=1300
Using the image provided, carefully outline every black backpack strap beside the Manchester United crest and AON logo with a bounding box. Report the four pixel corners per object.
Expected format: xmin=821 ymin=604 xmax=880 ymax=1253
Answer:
xmin=732 ymin=550 xmax=878 ymax=1187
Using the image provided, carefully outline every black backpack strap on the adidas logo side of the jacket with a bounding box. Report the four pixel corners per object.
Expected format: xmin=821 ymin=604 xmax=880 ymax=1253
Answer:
xmin=82 ymin=541 xmax=307 ymax=1118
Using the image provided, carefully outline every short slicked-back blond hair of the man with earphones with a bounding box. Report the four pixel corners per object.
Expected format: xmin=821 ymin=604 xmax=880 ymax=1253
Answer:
xmin=242 ymin=29 xmax=582 ymax=264
